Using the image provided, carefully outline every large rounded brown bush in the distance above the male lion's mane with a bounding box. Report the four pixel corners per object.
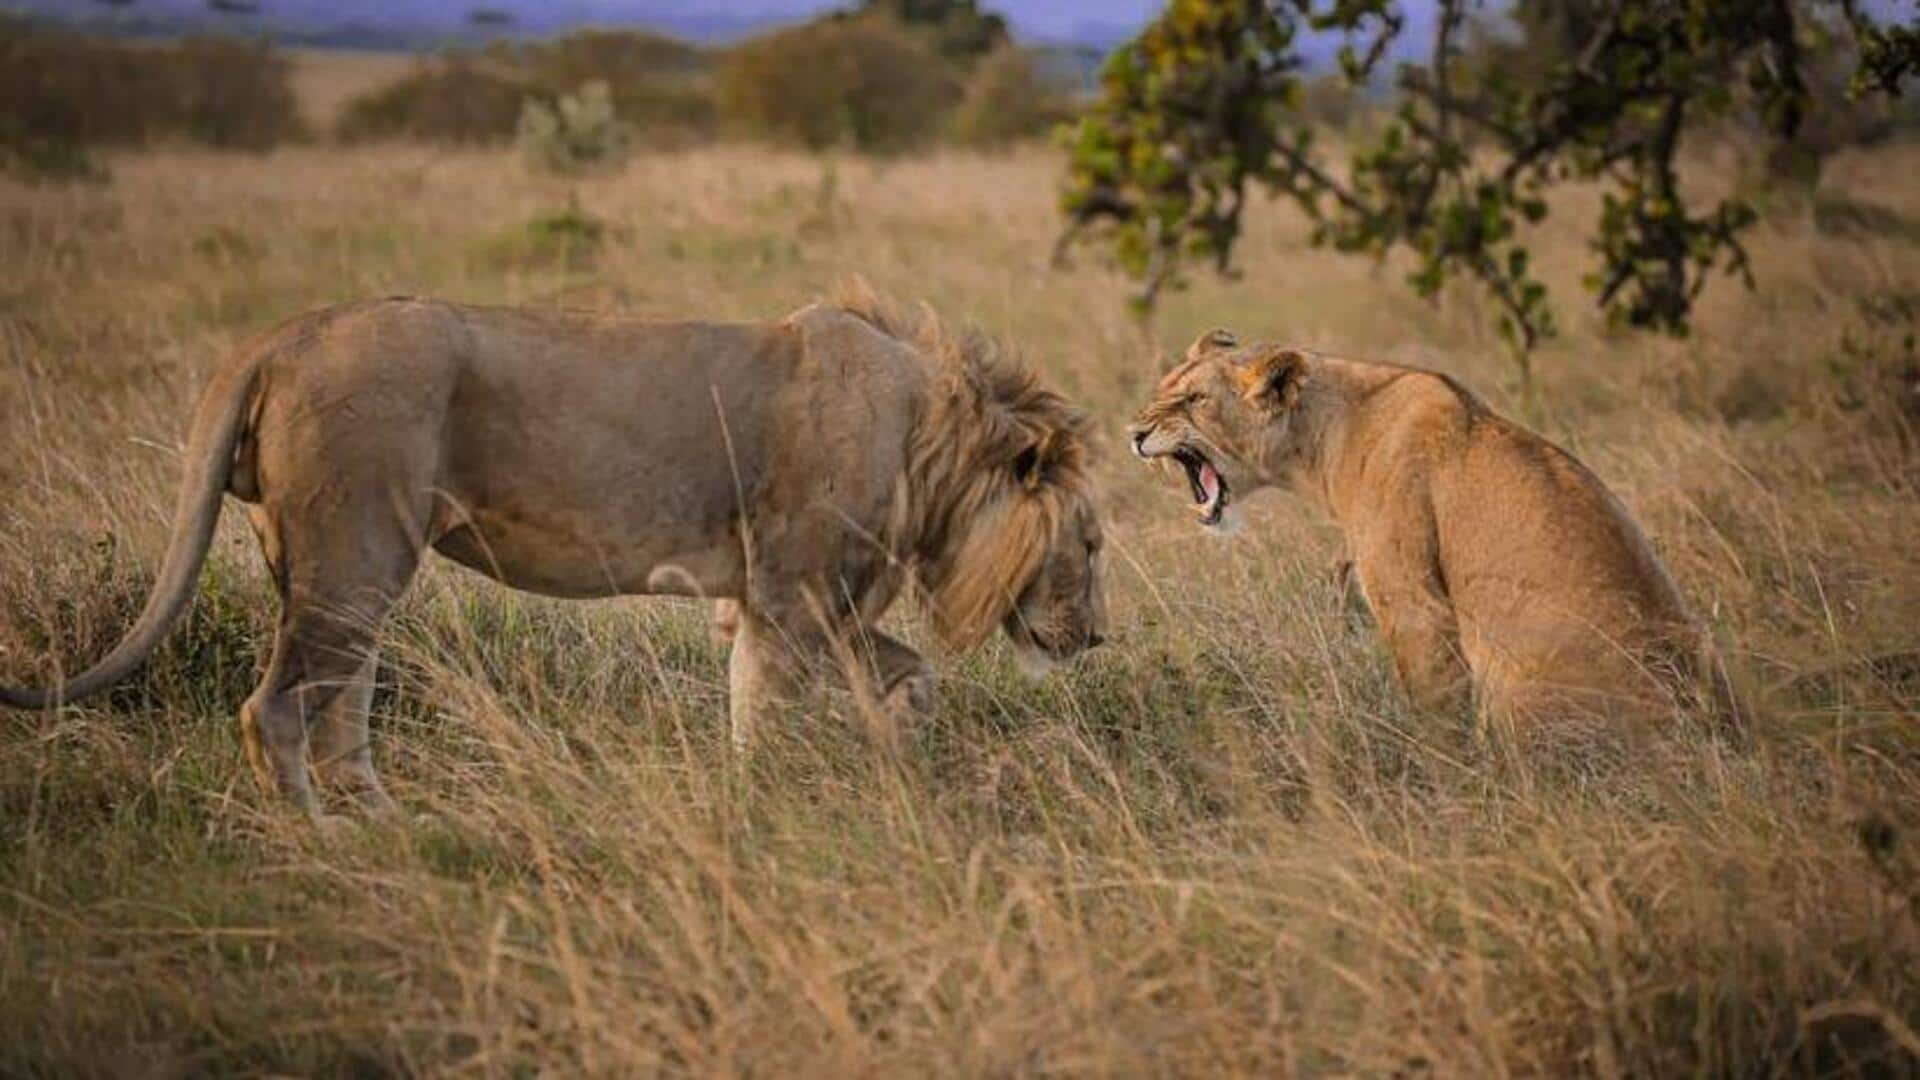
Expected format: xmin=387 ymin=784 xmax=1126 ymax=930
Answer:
xmin=720 ymin=17 xmax=960 ymax=150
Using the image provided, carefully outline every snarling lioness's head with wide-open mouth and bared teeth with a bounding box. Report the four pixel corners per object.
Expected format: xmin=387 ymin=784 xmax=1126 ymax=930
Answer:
xmin=1127 ymin=331 xmax=1313 ymax=527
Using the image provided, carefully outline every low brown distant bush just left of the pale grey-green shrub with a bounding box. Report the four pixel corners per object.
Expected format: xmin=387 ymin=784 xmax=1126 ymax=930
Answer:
xmin=336 ymin=56 xmax=538 ymax=142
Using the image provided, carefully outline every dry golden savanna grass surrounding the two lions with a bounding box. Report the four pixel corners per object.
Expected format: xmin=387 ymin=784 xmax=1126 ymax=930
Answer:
xmin=0 ymin=117 xmax=1920 ymax=1076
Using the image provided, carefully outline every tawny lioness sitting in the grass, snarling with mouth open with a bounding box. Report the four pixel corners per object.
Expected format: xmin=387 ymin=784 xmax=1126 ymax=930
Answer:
xmin=1129 ymin=331 xmax=1732 ymax=721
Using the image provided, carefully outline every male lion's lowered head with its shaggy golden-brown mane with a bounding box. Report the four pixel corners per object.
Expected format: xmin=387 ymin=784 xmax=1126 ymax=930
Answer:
xmin=839 ymin=288 xmax=1106 ymax=669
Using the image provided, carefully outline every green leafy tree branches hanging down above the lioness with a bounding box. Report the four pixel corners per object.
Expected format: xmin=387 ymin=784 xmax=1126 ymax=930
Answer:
xmin=1056 ymin=0 xmax=1920 ymax=382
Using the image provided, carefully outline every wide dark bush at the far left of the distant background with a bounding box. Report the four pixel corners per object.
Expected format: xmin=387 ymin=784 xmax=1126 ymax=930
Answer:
xmin=0 ymin=17 xmax=305 ymax=173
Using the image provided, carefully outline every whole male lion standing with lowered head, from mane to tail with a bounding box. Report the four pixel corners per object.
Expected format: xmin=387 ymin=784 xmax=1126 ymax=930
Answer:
xmin=0 ymin=286 xmax=1104 ymax=813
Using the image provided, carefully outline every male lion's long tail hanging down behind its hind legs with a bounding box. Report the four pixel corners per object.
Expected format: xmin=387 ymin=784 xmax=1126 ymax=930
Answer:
xmin=0 ymin=363 xmax=259 ymax=709
